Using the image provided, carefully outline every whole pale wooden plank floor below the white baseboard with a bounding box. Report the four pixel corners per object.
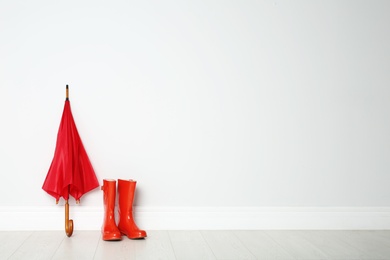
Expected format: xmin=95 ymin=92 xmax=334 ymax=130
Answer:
xmin=0 ymin=231 xmax=390 ymax=260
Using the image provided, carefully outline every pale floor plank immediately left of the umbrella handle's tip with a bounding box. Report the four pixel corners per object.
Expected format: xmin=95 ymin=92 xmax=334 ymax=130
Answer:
xmin=9 ymin=231 xmax=66 ymax=260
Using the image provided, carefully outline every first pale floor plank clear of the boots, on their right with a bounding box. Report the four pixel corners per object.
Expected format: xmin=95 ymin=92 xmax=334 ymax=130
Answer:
xmin=169 ymin=231 xmax=216 ymax=260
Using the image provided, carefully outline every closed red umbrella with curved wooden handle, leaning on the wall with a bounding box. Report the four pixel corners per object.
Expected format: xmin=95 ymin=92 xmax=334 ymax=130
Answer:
xmin=42 ymin=85 xmax=99 ymax=237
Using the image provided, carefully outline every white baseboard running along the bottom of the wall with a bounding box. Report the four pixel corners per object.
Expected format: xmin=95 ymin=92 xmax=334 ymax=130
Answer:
xmin=0 ymin=205 xmax=390 ymax=230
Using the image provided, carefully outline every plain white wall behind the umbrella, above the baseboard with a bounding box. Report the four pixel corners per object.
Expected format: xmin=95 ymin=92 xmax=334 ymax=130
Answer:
xmin=0 ymin=0 xmax=390 ymax=227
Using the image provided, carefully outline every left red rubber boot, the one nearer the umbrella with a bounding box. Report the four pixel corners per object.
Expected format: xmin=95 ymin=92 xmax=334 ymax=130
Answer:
xmin=102 ymin=180 xmax=122 ymax=240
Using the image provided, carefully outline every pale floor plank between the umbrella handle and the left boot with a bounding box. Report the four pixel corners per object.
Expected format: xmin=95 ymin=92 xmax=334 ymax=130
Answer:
xmin=52 ymin=231 xmax=100 ymax=260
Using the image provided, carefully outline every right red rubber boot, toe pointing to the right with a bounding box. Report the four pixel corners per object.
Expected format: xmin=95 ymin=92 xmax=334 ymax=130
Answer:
xmin=118 ymin=180 xmax=146 ymax=239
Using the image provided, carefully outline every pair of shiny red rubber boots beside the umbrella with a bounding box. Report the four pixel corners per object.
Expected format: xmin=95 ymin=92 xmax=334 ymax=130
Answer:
xmin=102 ymin=179 xmax=146 ymax=240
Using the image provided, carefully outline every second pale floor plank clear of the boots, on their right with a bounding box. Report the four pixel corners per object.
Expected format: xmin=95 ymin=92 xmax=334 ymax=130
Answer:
xmin=201 ymin=230 xmax=256 ymax=260
